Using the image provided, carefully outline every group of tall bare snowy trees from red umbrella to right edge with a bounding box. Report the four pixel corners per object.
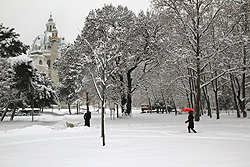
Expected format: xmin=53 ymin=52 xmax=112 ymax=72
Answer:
xmin=150 ymin=0 xmax=250 ymax=121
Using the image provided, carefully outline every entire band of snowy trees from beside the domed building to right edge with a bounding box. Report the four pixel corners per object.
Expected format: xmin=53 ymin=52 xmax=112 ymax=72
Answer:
xmin=55 ymin=0 xmax=249 ymax=121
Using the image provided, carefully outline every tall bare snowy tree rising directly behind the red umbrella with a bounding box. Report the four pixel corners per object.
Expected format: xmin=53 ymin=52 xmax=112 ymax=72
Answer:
xmin=152 ymin=0 xmax=229 ymax=121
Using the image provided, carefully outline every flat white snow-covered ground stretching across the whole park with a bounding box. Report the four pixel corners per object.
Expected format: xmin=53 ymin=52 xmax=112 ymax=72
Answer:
xmin=0 ymin=110 xmax=250 ymax=167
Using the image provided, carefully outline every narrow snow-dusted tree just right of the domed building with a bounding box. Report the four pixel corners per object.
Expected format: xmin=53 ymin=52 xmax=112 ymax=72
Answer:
xmin=54 ymin=44 xmax=85 ymax=114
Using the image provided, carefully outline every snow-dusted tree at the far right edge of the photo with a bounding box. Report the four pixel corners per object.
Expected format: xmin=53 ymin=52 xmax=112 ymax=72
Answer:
xmin=226 ymin=0 xmax=250 ymax=118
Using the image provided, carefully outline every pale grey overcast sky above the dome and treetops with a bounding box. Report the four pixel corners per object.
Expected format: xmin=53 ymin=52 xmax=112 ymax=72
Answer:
xmin=0 ymin=0 xmax=150 ymax=45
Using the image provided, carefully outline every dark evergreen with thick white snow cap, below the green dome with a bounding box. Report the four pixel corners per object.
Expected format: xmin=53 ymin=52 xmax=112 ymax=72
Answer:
xmin=10 ymin=55 xmax=58 ymax=118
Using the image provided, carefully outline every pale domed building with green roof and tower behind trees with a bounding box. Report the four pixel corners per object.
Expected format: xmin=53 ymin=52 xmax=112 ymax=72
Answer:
xmin=29 ymin=14 xmax=68 ymax=85
